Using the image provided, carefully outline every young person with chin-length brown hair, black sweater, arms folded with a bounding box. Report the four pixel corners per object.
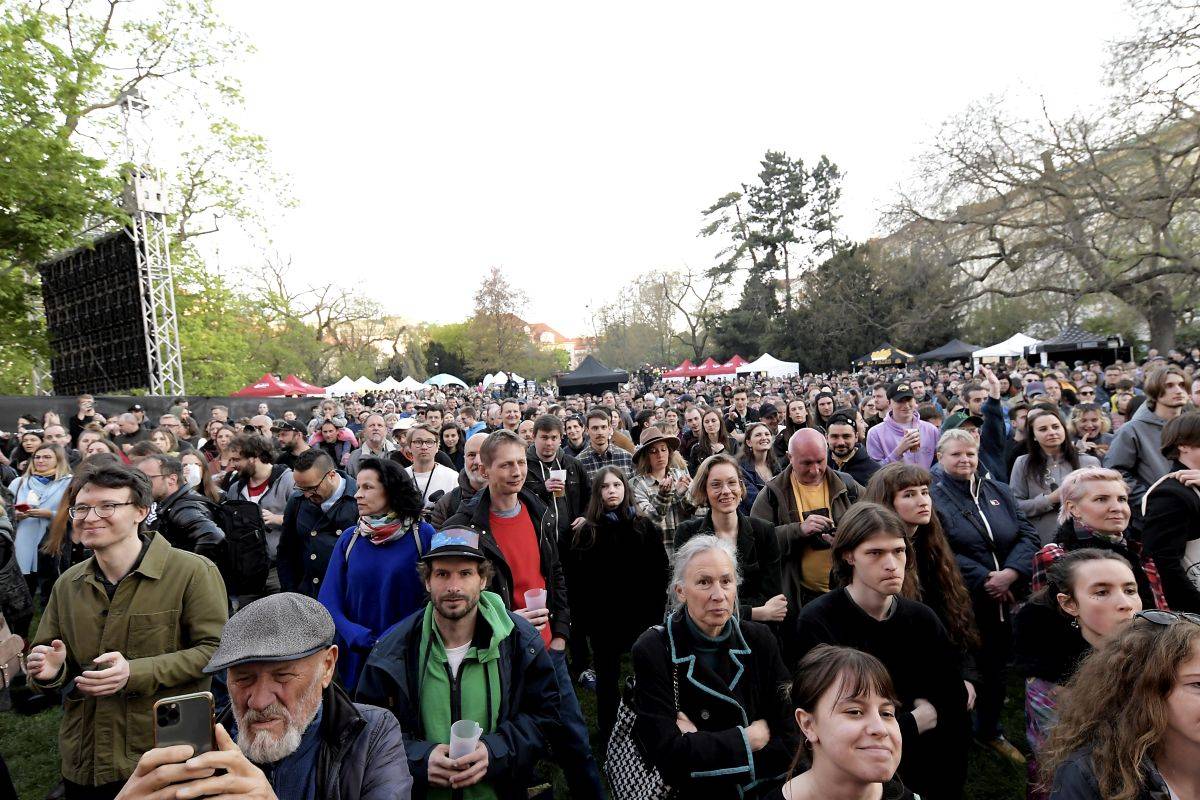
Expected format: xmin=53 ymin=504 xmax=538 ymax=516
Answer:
xmin=796 ymin=501 xmax=968 ymax=800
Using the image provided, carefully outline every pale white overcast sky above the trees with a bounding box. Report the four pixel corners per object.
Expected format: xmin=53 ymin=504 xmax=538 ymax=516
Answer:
xmin=206 ymin=0 xmax=1128 ymax=336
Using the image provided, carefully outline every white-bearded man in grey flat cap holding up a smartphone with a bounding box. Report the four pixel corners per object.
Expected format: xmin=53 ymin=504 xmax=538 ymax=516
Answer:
xmin=118 ymin=593 xmax=413 ymax=800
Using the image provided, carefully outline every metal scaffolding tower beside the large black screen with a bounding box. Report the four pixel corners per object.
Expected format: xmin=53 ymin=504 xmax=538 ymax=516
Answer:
xmin=121 ymin=92 xmax=184 ymax=395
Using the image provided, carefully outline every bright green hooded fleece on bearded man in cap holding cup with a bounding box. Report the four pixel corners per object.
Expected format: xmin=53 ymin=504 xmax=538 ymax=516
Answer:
xmin=420 ymin=591 xmax=514 ymax=800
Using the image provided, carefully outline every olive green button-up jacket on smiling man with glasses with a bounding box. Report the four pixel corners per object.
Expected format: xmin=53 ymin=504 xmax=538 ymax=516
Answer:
xmin=32 ymin=534 xmax=229 ymax=786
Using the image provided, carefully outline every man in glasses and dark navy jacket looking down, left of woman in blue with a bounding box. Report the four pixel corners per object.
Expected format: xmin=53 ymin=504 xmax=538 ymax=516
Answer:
xmin=277 ymin=449 xmax=359 ymax=597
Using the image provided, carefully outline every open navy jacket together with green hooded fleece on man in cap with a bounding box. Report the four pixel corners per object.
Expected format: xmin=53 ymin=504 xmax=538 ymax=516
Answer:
xmin=358 ymin=591 xmax=558 ymax=800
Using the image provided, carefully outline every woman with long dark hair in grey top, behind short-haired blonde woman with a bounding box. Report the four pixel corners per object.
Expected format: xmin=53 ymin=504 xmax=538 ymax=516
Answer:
xmin=1008 ymin=407 xmax=1100 ymax=545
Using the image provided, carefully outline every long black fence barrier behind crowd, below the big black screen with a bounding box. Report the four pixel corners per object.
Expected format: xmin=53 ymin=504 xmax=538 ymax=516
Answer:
xmin=0 ymin=395 xmax=333 ymax=431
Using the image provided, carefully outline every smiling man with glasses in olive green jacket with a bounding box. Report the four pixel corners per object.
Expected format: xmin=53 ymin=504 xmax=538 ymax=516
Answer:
xmin=26 ymin=467 xmax=228 ymax=800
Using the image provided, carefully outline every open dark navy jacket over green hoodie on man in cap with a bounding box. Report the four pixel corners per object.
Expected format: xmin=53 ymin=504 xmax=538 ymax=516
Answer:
xmin=352 ymin=609 xmax=558 ymax=800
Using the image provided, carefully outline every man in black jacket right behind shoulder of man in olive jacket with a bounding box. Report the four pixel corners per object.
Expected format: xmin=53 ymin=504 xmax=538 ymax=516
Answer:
xmin=134 ymin=453 xmax=227 ymax=567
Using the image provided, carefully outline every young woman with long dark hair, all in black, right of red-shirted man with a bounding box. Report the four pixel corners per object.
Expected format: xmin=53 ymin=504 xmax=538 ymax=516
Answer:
xmin=562 ymin=467 xmax=667 ymax=739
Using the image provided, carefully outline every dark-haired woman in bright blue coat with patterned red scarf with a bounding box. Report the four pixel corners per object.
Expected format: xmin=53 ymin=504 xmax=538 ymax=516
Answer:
xmin=317 ymin=458 xmax=433 ymax=692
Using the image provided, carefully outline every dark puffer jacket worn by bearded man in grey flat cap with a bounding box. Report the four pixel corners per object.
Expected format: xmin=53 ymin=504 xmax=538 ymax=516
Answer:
xmin=217 ymin=684 xmax=413 ymax=800
